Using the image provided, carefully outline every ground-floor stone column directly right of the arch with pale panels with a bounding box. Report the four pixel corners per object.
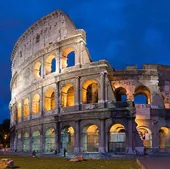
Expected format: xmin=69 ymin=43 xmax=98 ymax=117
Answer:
xmin=126 ymin=118 xmax=134 ymax=154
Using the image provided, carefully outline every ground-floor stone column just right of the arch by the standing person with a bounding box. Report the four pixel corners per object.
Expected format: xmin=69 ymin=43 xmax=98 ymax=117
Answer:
xmin=74 ymin=120 xmax=80 ymax=154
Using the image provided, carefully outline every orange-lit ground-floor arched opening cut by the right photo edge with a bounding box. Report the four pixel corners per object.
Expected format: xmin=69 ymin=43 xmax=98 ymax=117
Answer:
xmin=159 ymin=127 xmax=170 ymax=152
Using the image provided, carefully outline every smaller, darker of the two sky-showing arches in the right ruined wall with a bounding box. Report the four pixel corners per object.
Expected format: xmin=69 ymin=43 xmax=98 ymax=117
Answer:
xmin=115 ymin=87 xmax=127 ymax=102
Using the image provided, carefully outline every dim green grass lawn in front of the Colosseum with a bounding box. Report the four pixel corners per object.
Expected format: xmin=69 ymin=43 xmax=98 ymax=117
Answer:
xmin=0 ymin=156 xmax=139 ymax=169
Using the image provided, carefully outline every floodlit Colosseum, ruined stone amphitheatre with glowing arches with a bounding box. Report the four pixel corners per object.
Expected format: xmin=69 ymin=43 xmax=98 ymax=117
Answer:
xmin=9 ymin=10 xmax=170 ymax=154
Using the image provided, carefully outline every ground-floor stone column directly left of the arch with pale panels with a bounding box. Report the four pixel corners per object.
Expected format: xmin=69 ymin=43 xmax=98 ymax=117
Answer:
xmin=99 ymin=119 xmax=106 ymax=153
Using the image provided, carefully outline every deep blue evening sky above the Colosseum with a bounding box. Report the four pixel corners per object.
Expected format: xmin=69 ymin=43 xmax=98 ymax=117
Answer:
xmin=0 ymin=0 xmax=170 ymax=122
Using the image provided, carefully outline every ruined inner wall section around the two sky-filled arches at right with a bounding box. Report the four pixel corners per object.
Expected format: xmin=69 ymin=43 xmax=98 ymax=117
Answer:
xmin=112 ymin=65 xmax=164 ymax=108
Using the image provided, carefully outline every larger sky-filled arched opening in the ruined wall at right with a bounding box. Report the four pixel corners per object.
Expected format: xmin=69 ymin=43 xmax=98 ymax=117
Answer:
xmin=134 ymin=86 xmax=151 ymax=104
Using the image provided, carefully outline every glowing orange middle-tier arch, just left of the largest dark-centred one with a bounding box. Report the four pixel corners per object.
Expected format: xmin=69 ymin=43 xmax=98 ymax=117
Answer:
xmin=61 ymin=84 xmax=74 ymax=107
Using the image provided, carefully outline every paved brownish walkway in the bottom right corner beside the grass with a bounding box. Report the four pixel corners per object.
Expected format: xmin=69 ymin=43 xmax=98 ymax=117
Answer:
xmin=138 ymin=156 xmax=170 ymax=169
